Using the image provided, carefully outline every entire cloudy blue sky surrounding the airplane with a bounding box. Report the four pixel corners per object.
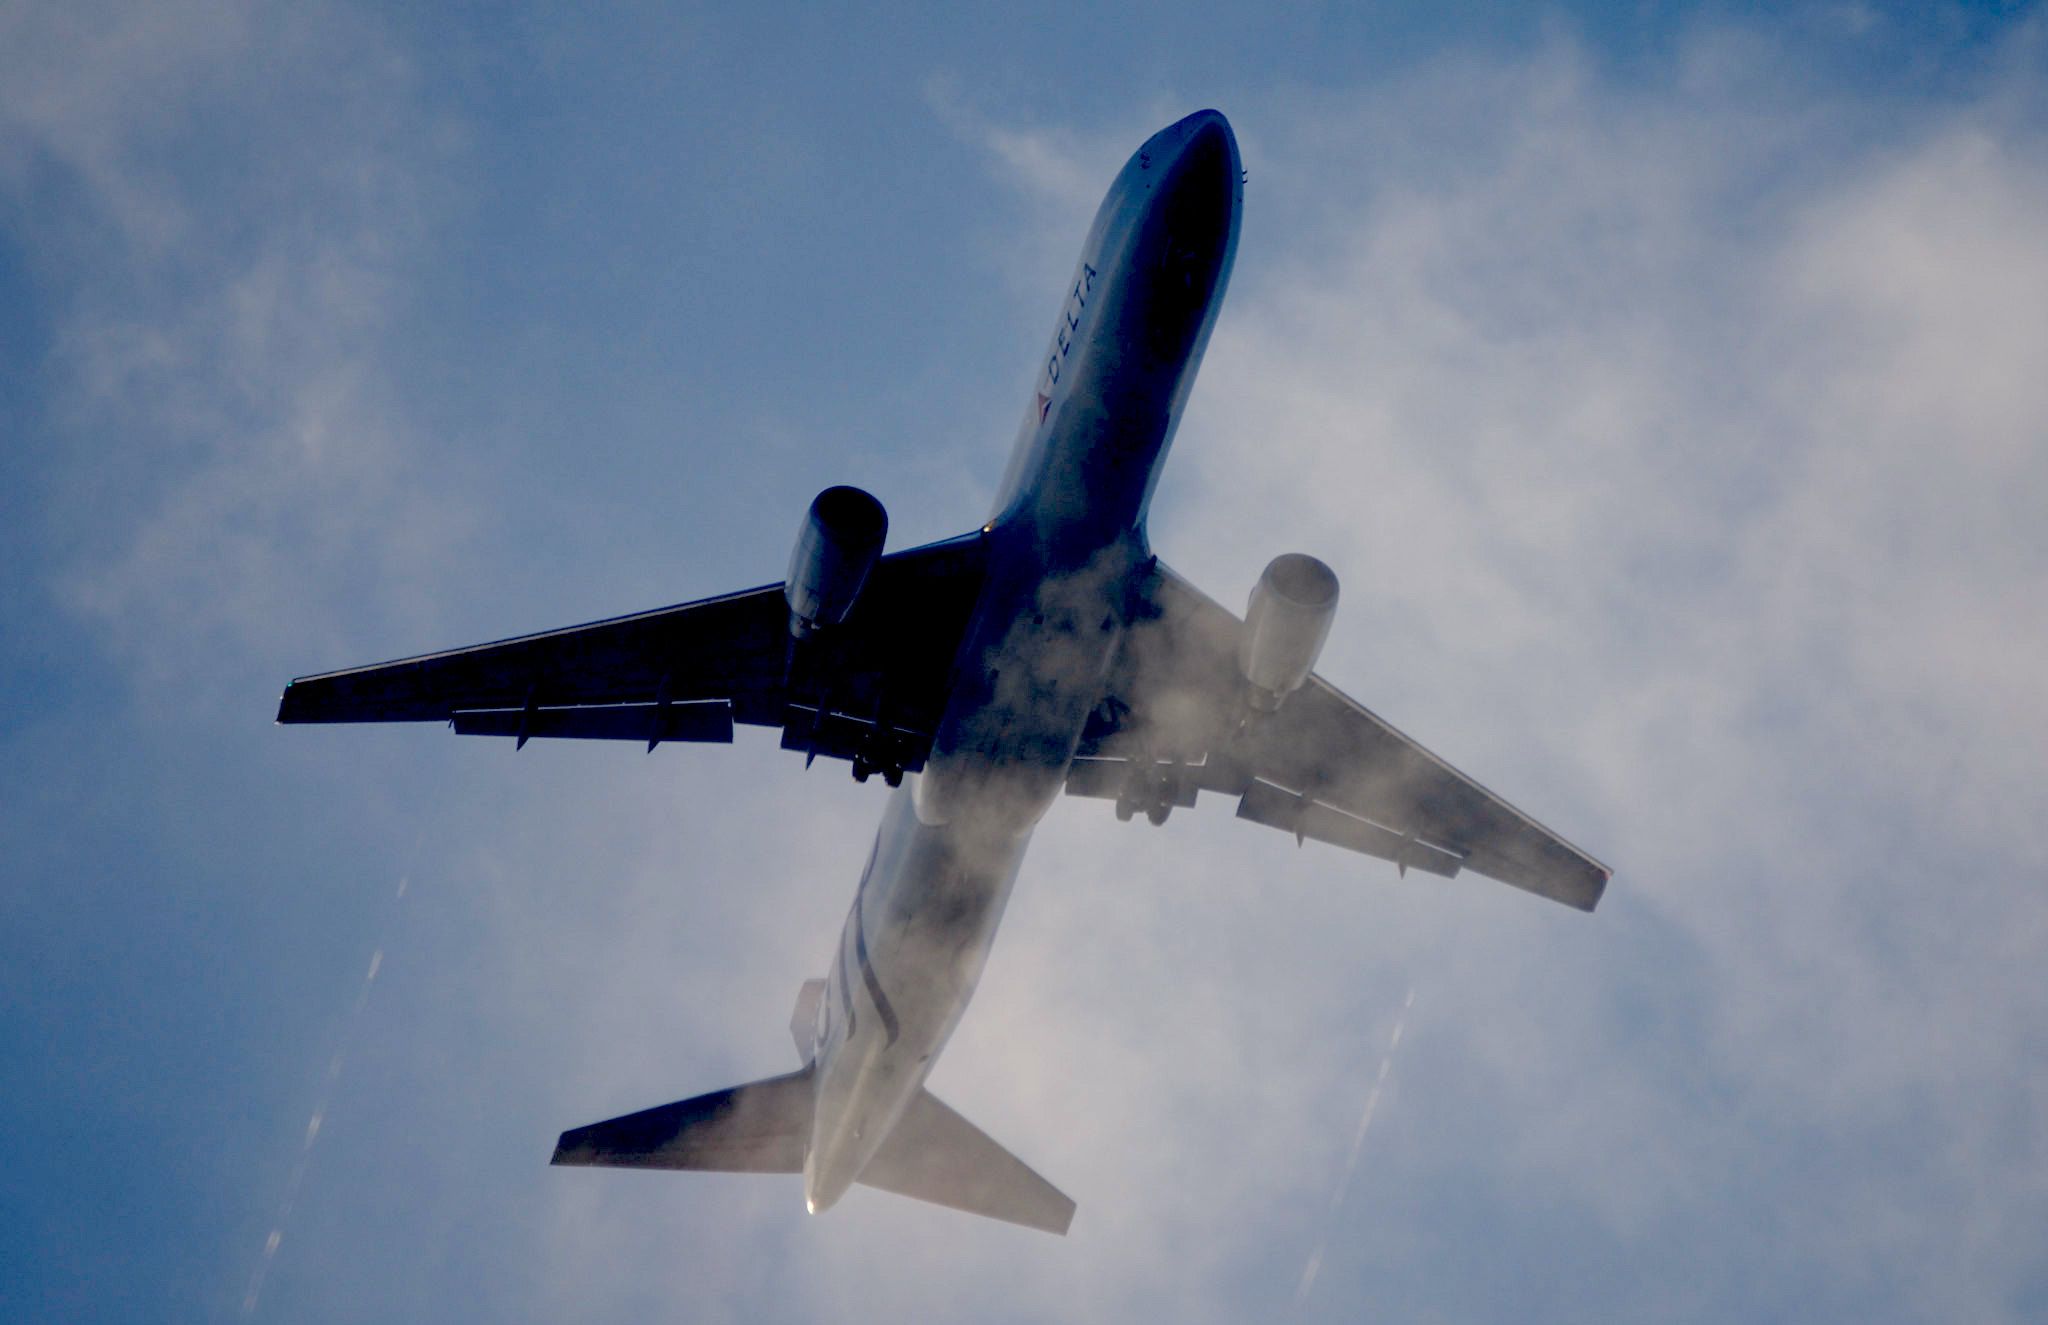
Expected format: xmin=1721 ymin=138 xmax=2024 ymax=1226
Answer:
xmin=0 ymin=2 xmax=2048 ymax=1321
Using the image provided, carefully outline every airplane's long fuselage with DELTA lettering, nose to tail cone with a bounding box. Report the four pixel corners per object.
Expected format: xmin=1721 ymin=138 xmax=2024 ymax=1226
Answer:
xmin=803 ymin=111 xmax=1243 ymax=1210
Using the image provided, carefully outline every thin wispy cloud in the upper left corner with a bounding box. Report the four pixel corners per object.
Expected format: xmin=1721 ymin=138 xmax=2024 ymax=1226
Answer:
xmin=0 ymin=4 xmax=467 ymax=704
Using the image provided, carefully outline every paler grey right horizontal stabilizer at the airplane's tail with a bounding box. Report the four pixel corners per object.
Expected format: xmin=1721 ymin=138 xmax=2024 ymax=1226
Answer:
xmin=860 ymin=1089 xmax=1073 ymax=1233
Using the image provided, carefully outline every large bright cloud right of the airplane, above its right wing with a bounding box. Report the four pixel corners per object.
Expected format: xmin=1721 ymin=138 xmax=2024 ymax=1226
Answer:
xmin=1187 ymin=41 xmax=2048 ymax=1315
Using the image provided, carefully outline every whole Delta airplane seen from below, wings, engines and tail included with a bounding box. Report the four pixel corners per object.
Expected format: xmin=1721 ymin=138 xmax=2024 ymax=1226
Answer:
xmin=276 ymin=111 xmax=1610 ymax=1235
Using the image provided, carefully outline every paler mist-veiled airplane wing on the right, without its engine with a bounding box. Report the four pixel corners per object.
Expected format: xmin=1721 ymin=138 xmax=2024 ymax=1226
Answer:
xmin=1067 ymin=561 xmax=1610 ymax=911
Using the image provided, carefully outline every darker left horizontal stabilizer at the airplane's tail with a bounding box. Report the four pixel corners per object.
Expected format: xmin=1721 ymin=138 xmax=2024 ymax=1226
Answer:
xmin=549 ymin=1067 xmax=811 ymax=1173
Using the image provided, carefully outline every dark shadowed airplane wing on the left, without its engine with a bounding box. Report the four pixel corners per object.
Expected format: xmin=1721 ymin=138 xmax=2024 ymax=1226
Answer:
xmin=276 ymin=535 xmax=985 ymax=772
